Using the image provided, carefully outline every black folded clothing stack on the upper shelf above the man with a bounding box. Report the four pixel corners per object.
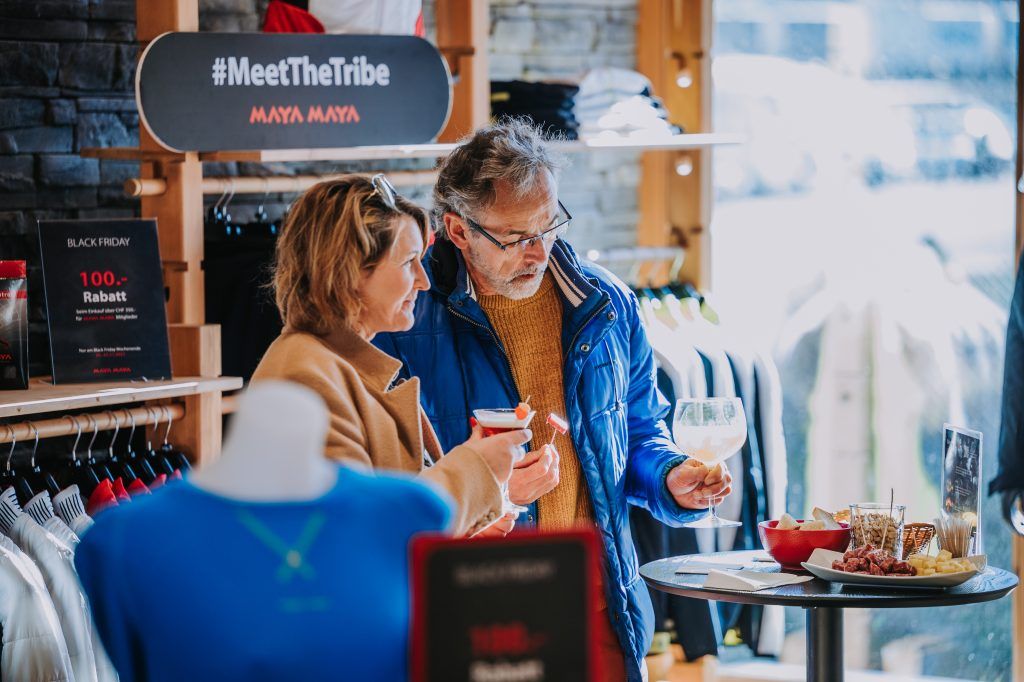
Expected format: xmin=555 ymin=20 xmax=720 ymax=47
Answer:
xmin=490 ymin=81 xmax=580 ymax=139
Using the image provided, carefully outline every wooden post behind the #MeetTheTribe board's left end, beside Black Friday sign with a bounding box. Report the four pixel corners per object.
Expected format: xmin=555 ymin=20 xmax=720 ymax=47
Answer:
xmin=135 ymin=0 xmax=221 ymax=461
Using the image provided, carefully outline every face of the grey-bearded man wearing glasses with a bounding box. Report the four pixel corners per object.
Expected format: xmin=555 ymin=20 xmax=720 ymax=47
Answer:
xmin=444 ymin=171 xmax=558 ymax=299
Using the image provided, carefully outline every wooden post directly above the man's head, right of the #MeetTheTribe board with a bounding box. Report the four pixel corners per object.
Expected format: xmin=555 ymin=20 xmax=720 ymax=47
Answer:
xmin=436 ymin=0 xmax=490 ymax=142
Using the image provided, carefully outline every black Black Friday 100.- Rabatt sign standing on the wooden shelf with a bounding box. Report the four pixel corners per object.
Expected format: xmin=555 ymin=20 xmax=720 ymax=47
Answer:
xmin=39 ymin=220 xmax=171 ymax=384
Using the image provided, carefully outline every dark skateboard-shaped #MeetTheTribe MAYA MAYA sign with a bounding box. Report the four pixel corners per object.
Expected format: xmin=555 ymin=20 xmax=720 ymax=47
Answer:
xmin=135 ymin=33 xmax=451 ymax=152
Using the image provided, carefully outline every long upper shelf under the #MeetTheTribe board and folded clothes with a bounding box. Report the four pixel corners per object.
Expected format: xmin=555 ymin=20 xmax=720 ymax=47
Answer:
xmin=75 ymin=133 xmax=744 ymax=163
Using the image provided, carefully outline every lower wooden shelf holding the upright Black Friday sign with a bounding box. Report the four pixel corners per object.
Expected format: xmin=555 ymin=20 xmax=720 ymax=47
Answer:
xmin=0 ymin=377 xmax=242 ymax=418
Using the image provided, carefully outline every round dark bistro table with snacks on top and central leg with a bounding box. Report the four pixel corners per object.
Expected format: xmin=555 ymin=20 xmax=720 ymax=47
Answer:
xmin=640 ymin=551 xmax=1017 ymax=682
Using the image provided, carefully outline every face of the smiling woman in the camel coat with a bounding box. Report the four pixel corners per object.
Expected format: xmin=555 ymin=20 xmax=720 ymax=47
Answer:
xmin=358 ymin=215 xmax=430 ymax=339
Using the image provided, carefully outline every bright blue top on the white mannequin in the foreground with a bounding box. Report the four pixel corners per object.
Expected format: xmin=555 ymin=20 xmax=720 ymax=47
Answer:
xmin=75 ymin=467 xmax=452 ymax=682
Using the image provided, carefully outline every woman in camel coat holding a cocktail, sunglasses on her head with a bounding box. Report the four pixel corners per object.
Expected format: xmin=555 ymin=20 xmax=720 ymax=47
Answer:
xmin=253 ymin=175 xmax=530 ymax=535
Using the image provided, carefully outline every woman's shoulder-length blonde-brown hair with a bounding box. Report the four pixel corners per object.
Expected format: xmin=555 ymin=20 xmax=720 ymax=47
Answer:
xmin=273 ymin=175 xmax=429 ymax=335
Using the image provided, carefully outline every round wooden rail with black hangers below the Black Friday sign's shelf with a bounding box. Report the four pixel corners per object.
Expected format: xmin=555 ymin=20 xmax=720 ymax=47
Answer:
xmin=0 ymin=402 xmax=185 ymax=443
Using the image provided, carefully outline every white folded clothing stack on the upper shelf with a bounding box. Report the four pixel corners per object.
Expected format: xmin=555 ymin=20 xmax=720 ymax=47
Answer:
xmin=573 ymin=67 xmax=682 ymax=141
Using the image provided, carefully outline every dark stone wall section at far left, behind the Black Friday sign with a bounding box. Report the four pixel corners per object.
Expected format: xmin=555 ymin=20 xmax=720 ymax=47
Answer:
xmin=0 ymin=0 xmax=138 ymax=376
